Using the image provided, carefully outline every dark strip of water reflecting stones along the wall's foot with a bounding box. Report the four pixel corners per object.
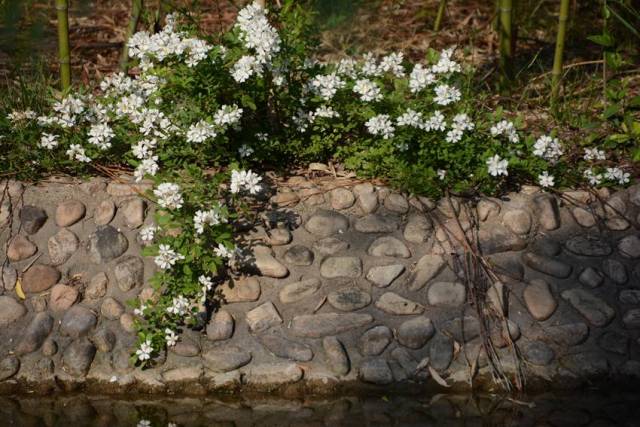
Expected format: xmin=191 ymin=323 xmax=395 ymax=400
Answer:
xmin=0 ymin=391 xmax=640 ymax=427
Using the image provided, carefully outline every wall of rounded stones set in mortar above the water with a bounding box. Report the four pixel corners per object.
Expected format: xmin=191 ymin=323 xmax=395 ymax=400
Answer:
xmin=0 ymin=177 xmax=640 ymax=394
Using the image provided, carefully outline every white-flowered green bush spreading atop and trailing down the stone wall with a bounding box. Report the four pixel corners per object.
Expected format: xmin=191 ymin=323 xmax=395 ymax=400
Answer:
xmin=2 ymin=1 xmax=629 ymax=366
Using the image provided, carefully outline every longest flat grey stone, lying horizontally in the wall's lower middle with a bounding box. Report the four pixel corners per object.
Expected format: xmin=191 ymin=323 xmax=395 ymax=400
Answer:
xmin=290 ymin=313 xmax=373 ymax=338
